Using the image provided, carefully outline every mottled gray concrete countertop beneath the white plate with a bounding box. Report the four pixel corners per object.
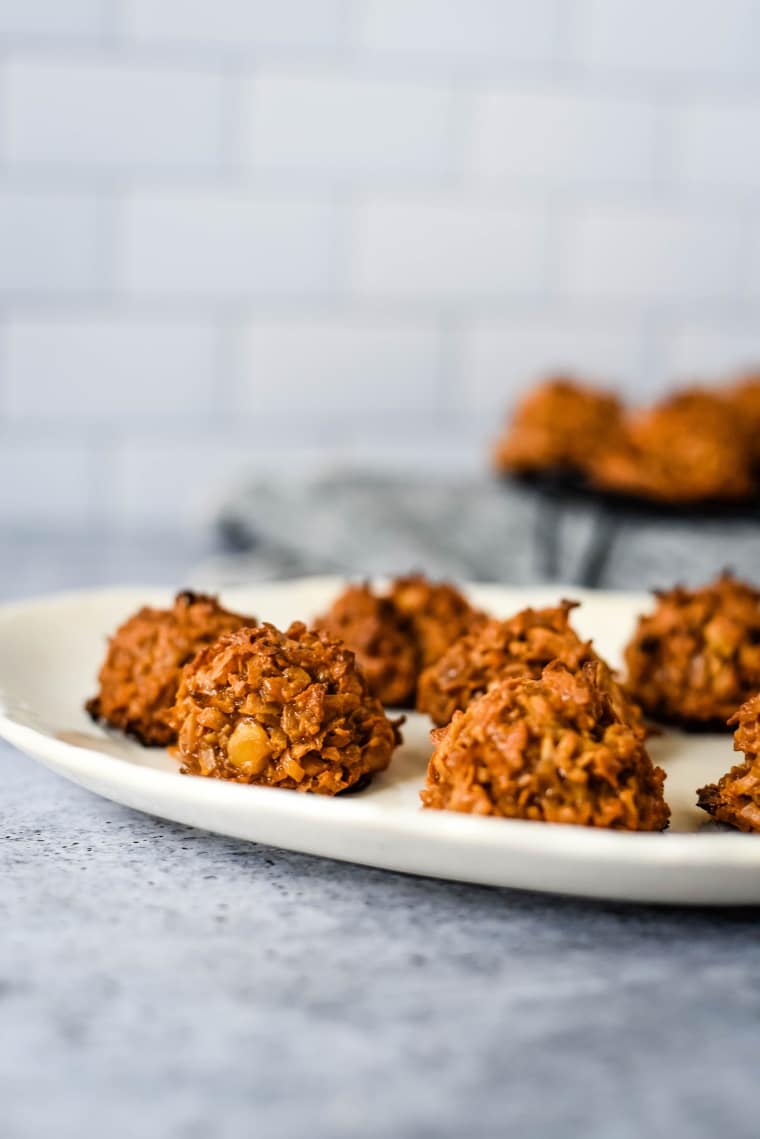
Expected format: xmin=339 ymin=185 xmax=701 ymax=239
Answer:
xmin=0 ymin=535 xmax=760 ymax=1139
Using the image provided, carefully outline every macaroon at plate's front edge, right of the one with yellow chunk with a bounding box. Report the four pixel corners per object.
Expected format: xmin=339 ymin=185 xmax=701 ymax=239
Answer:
xmin=420 ymin=662 xmax=670 ymax=830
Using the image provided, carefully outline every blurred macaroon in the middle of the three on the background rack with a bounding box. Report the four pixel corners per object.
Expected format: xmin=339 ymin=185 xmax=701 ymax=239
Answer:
xmin=585 ymin=388 xmax=754 ymax=506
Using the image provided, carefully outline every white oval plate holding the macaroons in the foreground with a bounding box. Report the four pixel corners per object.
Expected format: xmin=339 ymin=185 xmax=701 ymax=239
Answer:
xmin=0 ymin=577 xmax=760 ymax=906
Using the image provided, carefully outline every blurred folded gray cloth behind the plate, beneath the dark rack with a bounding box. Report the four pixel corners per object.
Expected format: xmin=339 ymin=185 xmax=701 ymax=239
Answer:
xmin=195 ymin=470 xmax=760 ymax=589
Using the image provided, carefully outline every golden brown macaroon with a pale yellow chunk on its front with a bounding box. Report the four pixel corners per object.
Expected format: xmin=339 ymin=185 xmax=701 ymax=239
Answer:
xmin=173 ymin=622 xmax=400 ymax=795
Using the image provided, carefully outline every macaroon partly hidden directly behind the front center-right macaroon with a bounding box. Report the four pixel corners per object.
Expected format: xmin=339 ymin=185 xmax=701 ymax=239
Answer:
xmin=417 ymin=601 xmax=643 ymax=731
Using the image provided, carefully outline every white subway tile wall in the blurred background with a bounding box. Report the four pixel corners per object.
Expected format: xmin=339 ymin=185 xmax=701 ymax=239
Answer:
xmin=0 ymin=0 xmax=760 ymax=525
